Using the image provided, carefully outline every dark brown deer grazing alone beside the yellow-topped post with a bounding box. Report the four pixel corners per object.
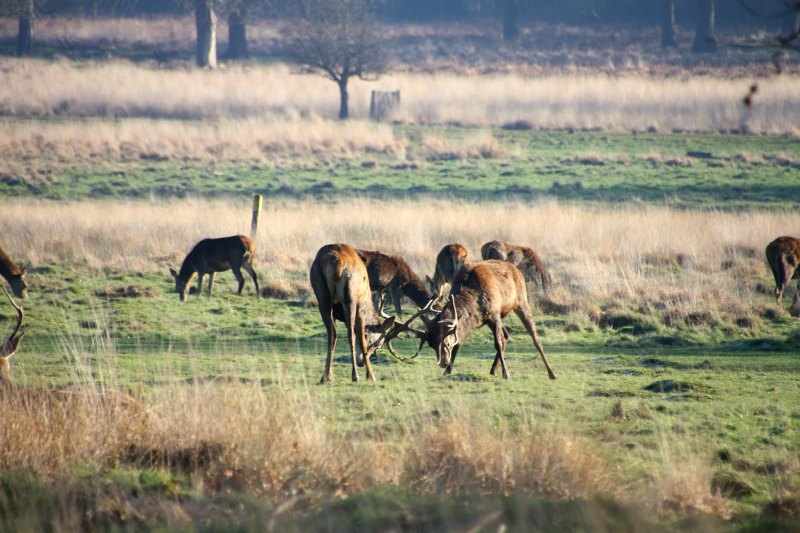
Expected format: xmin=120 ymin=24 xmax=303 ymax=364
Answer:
xmin=169 ymin=235 xmax=259 ymax=302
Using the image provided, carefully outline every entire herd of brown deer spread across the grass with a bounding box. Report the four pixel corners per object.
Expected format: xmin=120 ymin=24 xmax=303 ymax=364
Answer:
xmin=0 ymin=235 xmax=800 ymax=385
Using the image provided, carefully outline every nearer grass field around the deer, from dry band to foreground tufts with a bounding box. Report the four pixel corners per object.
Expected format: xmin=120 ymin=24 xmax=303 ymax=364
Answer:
xmin=0 ymin=198 xmax=800 ymax=531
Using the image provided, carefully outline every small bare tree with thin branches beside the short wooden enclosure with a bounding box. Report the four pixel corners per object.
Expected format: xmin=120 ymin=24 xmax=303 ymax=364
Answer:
xmin=289 ymin=0 xmax=386 ymax=120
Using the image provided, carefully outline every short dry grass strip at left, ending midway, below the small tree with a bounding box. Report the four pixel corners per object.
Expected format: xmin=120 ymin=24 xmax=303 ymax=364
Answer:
xmin=0 ymin=117 xmax=406 ymax=163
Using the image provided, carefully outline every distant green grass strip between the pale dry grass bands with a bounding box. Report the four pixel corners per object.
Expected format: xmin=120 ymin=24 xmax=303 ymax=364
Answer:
xmin=6 ymin=126 xmax=800 ymax=209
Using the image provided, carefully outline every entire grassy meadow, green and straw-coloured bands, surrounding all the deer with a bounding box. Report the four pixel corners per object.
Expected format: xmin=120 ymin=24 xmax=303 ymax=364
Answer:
xmin=0 ymin=17 xmax=800 ymax=532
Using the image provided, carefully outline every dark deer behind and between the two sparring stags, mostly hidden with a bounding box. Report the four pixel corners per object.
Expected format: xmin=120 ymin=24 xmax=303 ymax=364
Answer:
xmin=356 ymin=250 xmax=431 ymax=316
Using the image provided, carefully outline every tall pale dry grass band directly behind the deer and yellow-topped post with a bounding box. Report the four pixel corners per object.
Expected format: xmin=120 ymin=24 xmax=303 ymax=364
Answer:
xmin=0 ymin=199 xmax=800 ymax=324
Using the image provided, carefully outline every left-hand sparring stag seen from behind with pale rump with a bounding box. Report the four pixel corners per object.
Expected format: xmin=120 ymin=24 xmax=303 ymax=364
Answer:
xmin=309 ymin=244 xmax=394 ymax=383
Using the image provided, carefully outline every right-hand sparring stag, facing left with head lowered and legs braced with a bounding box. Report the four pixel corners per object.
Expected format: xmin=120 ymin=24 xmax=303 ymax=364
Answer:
xmin=386 ymin=260 xmax=556 ymax=379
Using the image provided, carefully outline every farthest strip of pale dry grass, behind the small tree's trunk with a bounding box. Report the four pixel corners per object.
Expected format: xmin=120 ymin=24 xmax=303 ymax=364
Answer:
xmin=0 ymin=59 xmax=800 ymax=134
